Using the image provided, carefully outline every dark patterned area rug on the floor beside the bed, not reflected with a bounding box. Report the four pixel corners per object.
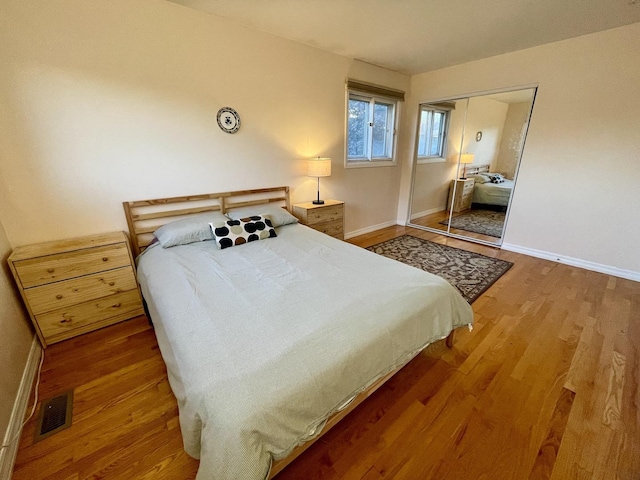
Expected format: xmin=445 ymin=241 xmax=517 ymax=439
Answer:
xmin=367 ymin=235 xmax=513 ymax=303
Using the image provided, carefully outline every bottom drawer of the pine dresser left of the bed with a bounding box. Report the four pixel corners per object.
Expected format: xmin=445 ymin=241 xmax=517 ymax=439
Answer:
xmin=35 ymin=289 xmax=142 ymax=343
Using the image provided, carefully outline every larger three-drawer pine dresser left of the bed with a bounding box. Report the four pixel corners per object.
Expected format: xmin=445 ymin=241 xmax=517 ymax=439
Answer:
xmin=8 ymin=232 xmax=144 ymax=348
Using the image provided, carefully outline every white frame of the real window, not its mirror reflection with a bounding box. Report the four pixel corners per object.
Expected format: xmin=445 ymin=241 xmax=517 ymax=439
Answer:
xmin=344 ymin=86 xmax=400 ymax=168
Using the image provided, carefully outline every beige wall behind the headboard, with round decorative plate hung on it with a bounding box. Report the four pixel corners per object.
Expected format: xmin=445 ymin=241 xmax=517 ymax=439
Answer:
xmin=0 ymin=0 xmax=409 ymax=246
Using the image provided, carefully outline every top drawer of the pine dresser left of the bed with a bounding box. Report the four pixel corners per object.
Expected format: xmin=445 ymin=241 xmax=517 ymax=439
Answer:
xmin=14 ymin=243 xmax=131 ymax=288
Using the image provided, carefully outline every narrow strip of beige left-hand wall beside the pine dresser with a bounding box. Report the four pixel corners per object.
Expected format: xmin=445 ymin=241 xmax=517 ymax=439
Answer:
xmin=0 ymin=216 xmax=34 ymax=441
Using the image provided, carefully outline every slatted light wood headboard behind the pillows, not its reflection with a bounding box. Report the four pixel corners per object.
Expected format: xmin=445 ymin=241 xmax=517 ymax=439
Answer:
xmin=122 ymin=187 xmax=291 ymax=256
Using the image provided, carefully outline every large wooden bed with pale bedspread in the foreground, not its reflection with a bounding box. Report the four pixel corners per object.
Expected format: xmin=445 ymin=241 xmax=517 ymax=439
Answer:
xmin=124 ymin=187 xmax=473 ymax=480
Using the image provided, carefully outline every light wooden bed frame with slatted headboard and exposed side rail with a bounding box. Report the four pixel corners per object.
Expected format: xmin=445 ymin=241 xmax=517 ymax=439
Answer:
xmin=122 ymin=186 xmax=456 ymax=478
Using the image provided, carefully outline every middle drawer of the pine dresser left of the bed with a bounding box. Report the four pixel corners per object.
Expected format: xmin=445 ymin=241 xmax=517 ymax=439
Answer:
xmin=24 ymin=266 xmax=137 ymax=315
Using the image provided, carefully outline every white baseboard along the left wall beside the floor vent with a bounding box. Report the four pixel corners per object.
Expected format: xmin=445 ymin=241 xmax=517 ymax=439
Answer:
xmin=0 ymin=336 xmax=42 ymax=480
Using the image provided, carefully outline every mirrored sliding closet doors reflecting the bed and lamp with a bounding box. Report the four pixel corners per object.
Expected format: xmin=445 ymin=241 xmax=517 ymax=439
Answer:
xmin=409 ymin=88 xmax=536 ymax=245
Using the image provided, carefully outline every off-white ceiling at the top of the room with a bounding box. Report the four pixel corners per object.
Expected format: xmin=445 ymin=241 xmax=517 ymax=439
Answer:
xmin=164 ymin=0 xmax=640 ymax=75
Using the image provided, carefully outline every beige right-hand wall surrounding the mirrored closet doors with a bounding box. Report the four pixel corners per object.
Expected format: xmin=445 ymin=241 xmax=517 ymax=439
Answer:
xmin=398 ymin=23 xmax=640 ymax=273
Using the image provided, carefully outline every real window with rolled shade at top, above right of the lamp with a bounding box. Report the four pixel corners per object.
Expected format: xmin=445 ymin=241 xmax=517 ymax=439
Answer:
xmin=345 ymin=80 xmax=404 ymax=167
